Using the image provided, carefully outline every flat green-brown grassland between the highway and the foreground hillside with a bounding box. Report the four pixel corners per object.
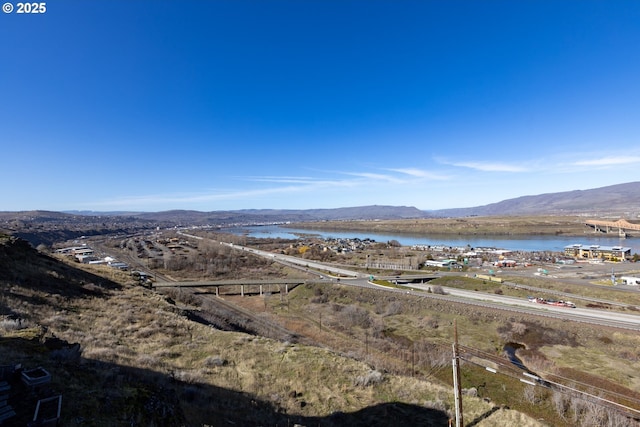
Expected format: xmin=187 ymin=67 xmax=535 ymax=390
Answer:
xmin=252 ymin=287 xmax=639 ymax=425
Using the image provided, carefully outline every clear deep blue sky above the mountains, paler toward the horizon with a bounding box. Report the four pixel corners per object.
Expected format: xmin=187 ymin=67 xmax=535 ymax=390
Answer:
xmin=0 ymin=0 xmax=640 ymax=211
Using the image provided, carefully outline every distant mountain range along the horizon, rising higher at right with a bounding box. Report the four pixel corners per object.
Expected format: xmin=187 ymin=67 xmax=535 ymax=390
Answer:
xmin=0 ymin=182 xmax=640 ymax=226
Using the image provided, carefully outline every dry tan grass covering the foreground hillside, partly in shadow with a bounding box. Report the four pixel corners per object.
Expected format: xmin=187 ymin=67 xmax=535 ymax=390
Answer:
xmin=0 ymin=256 xmax=540 ymax=426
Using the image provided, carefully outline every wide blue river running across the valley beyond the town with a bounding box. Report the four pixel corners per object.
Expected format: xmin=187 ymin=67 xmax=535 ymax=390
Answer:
xmin=225 ymin=225 xmax=640 ymax=254
